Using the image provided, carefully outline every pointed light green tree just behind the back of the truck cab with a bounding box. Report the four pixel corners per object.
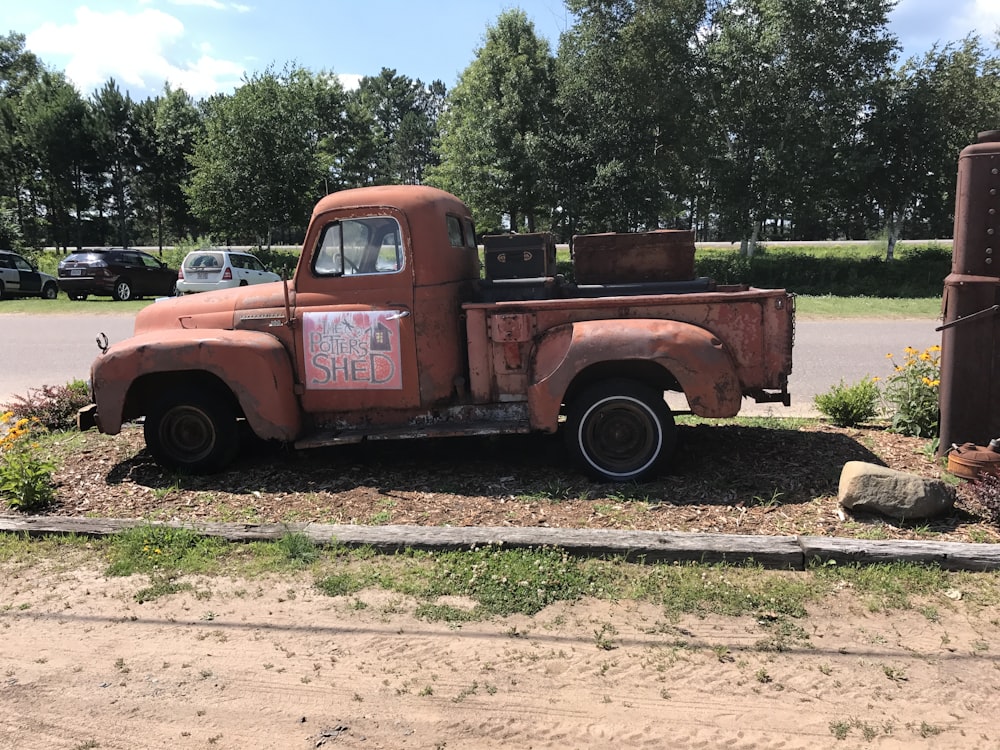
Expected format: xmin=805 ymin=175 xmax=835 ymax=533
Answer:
xmin=427 ymin=10 xmax=555 ymax=231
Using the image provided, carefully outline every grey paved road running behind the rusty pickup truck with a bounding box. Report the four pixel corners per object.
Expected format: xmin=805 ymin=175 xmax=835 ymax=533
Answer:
xmin=0 ymin=314 xmax=941 ymax=416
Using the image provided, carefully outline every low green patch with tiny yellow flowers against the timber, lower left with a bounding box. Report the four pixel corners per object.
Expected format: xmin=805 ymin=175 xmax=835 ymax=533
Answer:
xmin=107 ymin=526 xmax=229 ymax=576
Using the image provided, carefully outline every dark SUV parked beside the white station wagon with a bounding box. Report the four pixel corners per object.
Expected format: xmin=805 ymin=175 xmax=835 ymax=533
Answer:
xmin=59 ymin=247 xmax=177 ymax=301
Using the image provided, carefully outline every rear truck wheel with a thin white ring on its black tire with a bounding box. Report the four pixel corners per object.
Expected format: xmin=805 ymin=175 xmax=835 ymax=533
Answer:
xmin=565 ymin=379 xmax=677 ymax=482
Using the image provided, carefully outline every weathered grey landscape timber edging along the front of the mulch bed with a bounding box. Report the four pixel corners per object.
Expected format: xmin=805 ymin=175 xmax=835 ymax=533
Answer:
xmin=0 ymin=516 xmax=1000 ymax=572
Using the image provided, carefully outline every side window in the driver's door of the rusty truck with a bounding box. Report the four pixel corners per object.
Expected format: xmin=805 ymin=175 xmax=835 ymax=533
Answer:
xmin=313 ymin=216 xmax=403 ymax=276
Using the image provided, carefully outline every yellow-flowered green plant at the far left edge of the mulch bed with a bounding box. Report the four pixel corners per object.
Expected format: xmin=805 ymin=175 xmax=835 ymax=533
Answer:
xmin=0 ymin=411 xmax=55 ymax=513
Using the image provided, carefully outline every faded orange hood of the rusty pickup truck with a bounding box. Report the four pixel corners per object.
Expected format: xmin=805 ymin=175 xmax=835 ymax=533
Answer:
xmin=135 ymin=281 xmax=295 ymax=334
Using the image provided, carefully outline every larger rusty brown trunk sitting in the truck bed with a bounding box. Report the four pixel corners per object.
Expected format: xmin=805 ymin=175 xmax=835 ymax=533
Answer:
xmin=573 ymin=229 xmax=694 ymax=284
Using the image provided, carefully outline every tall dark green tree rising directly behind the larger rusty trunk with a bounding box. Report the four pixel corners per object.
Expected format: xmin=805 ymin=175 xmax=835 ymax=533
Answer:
xmin=549 ymin=0 xmax=705 ymax=231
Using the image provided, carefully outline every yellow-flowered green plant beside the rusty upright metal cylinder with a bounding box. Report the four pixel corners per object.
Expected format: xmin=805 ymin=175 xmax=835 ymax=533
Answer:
xmin=884 ymin=345 xmax=941 ymax=438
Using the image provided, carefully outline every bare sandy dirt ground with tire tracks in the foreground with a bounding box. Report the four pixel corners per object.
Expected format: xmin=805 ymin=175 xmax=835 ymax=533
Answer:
xmin=0 ymin=565 xmax=1000 ymax=750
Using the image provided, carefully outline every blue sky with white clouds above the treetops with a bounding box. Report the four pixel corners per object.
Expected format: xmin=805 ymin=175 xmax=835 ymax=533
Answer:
xmin=0 ymin=0 xmax=1000 ymax=99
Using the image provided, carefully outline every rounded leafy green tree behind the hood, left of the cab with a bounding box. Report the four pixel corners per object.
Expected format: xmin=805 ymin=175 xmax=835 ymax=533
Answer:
xmin=186 ymin=68 xmax=342 ymax=246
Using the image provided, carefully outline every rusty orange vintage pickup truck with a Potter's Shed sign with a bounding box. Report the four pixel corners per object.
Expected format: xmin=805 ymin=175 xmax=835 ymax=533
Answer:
xmin=80 ymin=186 xmax=794 ymax=481
